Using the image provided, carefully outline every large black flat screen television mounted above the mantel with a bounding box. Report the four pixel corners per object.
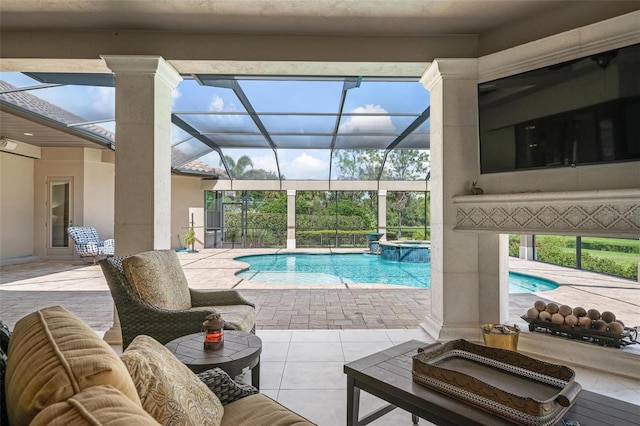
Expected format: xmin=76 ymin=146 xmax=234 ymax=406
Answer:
xmin=478 ymin=44 xmax=640 ymax=174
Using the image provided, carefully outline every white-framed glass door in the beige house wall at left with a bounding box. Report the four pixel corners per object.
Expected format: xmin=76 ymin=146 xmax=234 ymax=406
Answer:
xmin=46 ymin=177 xmax=73 ymax=256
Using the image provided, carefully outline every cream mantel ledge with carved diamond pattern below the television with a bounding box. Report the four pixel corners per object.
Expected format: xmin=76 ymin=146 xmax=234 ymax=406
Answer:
xmin=453 ymin=190 xmax=640 ymax=238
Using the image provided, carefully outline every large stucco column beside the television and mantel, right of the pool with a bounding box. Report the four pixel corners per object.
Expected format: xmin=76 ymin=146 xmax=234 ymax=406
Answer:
xmin=421 ymin=59 xmax=508 ymax=341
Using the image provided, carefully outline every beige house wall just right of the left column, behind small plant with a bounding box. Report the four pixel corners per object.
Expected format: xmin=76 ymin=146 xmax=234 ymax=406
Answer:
xmin=171 ymin=175 xmax=204 ymax=249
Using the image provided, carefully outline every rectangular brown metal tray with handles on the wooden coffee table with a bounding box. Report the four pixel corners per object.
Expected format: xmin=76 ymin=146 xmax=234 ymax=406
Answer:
xmin=412 ymin=339 xmax=582 ymax=426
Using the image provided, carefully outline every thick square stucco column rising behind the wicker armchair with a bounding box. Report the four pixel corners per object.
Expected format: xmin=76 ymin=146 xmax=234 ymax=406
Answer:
xmin=102 ymin=55 xmax=182 ymax=255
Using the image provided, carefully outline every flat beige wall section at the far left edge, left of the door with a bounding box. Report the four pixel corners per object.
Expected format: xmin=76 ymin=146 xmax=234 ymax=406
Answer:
xmin=0 ymin=152 xmax=35 ymax=262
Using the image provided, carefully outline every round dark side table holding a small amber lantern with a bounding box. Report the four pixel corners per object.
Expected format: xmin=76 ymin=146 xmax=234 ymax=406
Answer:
xmin=165 ymin=330 xmax=262 ymax=390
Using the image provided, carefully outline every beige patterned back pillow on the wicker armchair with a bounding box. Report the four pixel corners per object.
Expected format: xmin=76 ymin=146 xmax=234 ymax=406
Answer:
xmin=122 ymin=250 xmax=191 ymax=310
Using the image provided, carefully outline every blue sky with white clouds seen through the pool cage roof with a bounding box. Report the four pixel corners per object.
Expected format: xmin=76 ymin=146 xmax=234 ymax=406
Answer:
xmin=0 ymin=73 xmax=429 ymax=179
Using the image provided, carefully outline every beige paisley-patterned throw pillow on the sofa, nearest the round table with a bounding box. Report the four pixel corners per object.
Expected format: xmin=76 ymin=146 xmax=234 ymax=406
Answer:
xmin=120 ymin=335 xmax=224 ymax=426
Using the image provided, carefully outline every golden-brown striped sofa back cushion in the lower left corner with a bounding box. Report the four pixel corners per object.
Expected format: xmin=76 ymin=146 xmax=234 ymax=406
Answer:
xmin=6 ymin=306 xmax=140 ymax=425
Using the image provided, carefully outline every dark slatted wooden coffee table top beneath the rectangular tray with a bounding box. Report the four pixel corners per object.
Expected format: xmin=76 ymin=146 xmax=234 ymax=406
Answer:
xmin=344 ymin=340 xmax=640 ymax=426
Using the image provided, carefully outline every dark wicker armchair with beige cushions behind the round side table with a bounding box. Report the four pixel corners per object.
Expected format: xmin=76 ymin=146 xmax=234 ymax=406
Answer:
xmin=99 ymin=250 xmax=256 ymax=350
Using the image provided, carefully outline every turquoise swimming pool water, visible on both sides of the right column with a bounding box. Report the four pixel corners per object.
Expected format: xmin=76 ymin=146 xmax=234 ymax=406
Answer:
xmin=235 ymin=253 xmax=558 ymax=293
